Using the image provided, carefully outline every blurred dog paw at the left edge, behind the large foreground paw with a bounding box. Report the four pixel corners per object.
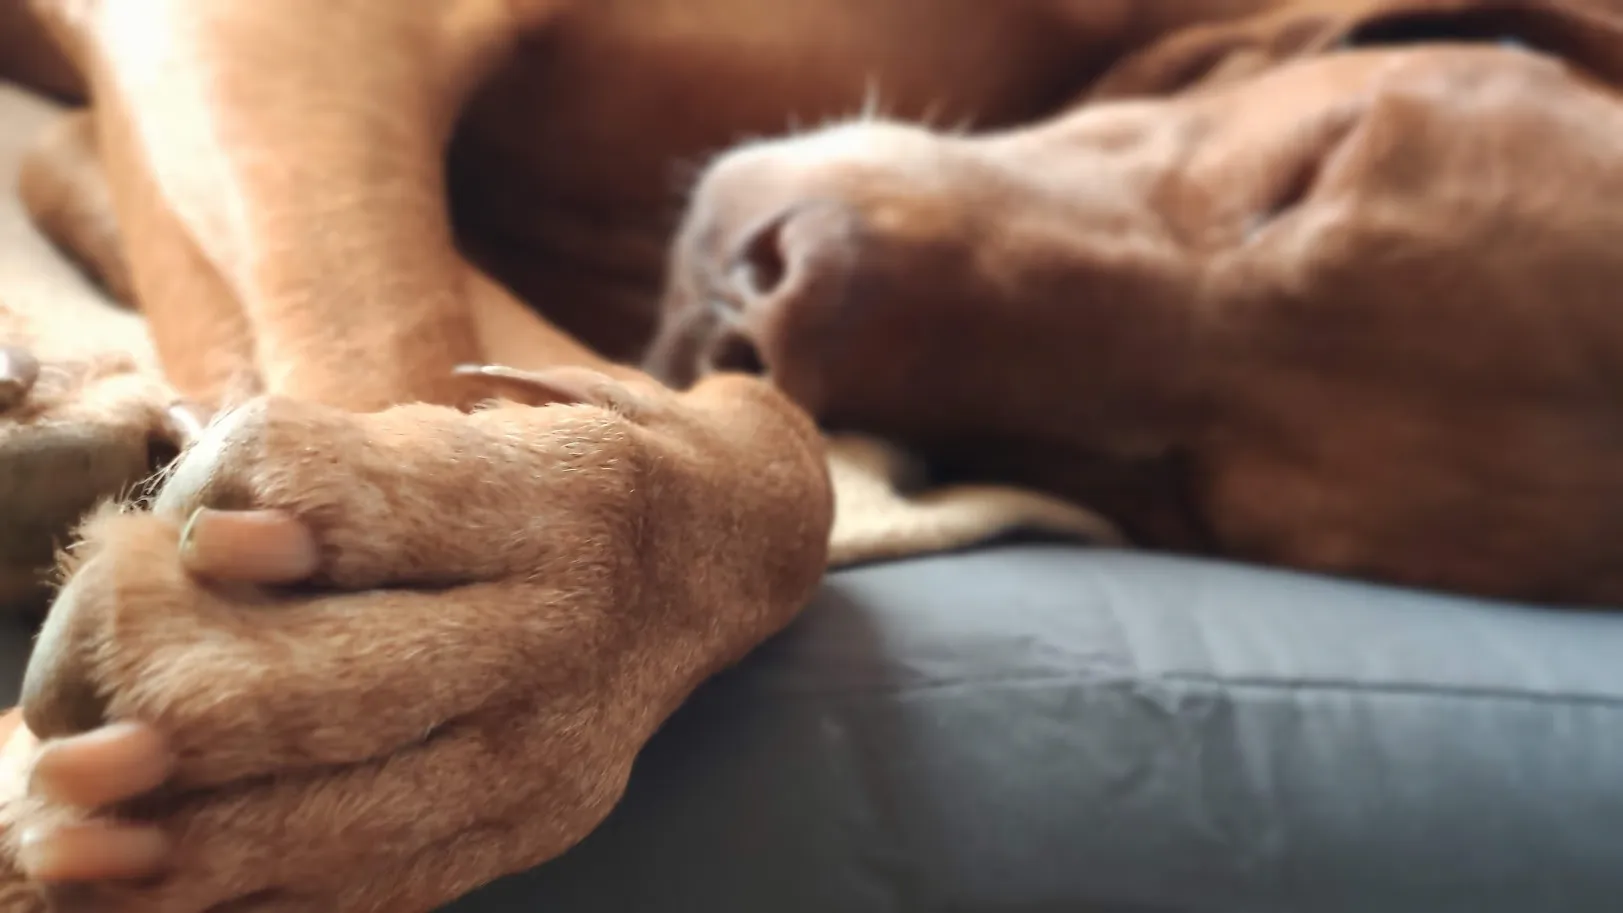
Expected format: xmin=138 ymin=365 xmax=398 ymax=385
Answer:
xmin=0 ymin=338 xmax=196 ymax=605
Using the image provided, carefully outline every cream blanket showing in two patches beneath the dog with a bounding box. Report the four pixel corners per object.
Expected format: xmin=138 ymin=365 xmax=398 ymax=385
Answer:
xmin=0 ymin=84 xmax=1120 ymax=566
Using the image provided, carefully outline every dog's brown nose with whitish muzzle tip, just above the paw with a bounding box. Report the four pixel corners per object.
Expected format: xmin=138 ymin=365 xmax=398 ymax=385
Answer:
xmin=643 ymin=125 xmax=938 ymax=398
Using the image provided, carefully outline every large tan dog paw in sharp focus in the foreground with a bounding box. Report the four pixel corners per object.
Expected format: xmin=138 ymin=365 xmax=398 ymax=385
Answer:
xmin=0 ymin=373 xmax=831 ymax=913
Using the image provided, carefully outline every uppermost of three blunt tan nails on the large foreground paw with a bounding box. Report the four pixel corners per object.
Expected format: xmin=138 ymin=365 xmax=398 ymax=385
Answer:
xmin=180 ymin=508 xmax=321 ymax=584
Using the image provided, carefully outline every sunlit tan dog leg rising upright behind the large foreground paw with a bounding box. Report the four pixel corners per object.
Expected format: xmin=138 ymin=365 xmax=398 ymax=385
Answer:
xmin=38 ymin=0 xmax=564 ymax=409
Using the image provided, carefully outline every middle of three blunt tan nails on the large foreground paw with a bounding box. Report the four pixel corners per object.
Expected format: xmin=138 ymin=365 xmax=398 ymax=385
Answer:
xmin=28 ymin=723 xmax=175 ymax=811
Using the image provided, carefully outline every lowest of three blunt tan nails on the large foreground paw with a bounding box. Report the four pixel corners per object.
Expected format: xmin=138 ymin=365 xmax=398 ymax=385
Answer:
xmin=16 ymin=822 xmax=169 ymax=884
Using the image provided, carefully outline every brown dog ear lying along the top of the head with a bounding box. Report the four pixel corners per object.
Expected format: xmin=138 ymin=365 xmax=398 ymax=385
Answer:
xmin=1086 ymin=0 xmax=1623 ymax=101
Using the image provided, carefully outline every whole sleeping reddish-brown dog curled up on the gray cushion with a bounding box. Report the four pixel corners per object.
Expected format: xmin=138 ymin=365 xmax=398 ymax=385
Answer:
xmin=0 ymin=0 xmax=1623 ymax=913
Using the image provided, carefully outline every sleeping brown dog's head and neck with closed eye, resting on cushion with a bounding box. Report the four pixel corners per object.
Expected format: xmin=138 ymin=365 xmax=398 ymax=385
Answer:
xmin=651 ymin=3 xmax=1623 ymax=605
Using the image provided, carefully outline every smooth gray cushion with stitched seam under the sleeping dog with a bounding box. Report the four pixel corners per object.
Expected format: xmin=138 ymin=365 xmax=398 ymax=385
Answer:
xmin=3 ymin=545 xmax=1623 ymax=913
